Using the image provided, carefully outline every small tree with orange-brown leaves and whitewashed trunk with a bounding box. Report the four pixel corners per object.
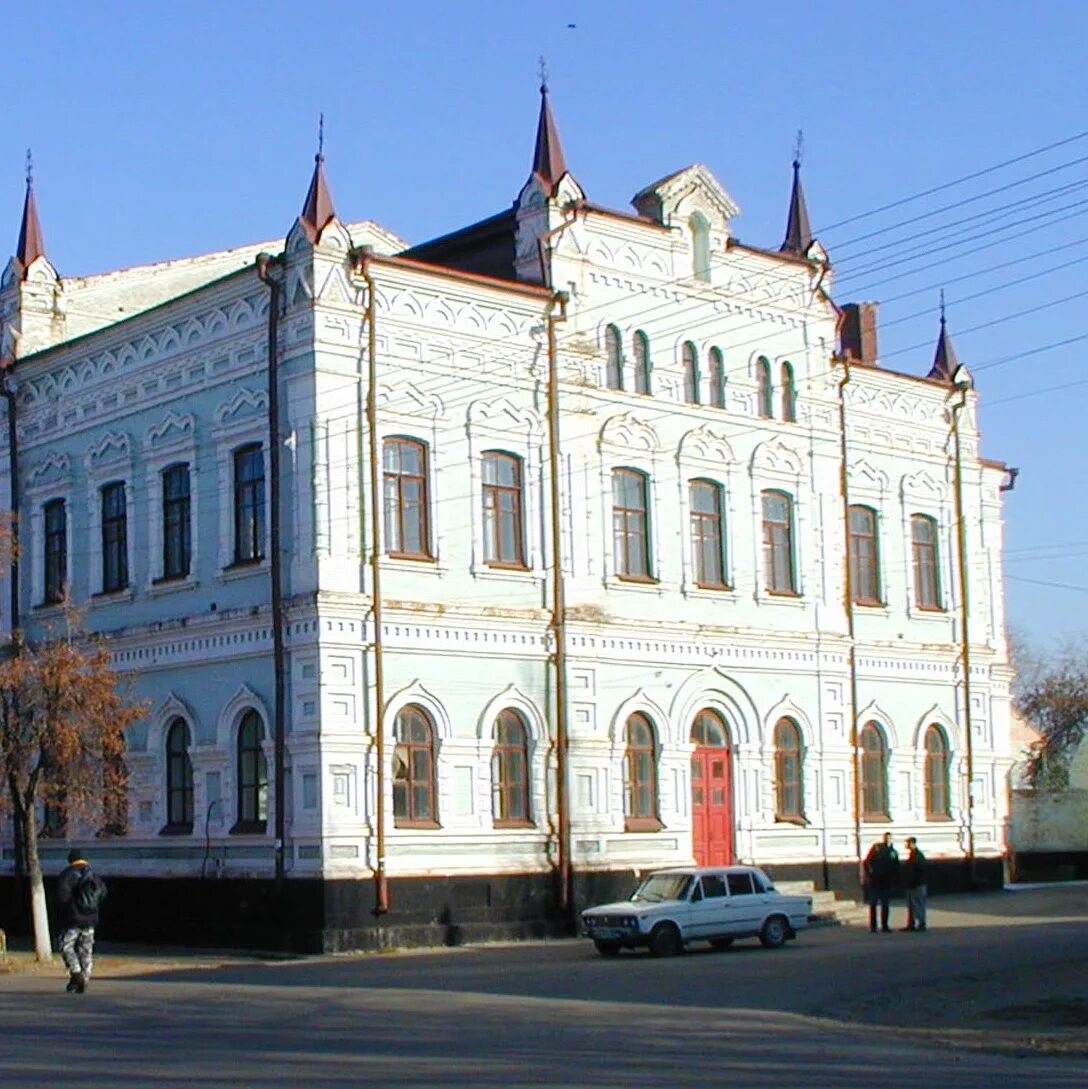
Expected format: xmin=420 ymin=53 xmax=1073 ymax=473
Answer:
xmin=0 ymin=632 xmax=146 ymax=959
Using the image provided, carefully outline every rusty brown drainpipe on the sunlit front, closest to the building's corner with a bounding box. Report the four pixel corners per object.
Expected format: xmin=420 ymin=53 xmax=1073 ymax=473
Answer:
xmin=358 ymin=246 xmax=389 ymax=916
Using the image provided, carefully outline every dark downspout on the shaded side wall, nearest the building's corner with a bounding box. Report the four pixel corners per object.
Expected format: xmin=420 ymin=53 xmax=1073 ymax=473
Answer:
xmin=257 ymin=254 xmax=286 ymax=893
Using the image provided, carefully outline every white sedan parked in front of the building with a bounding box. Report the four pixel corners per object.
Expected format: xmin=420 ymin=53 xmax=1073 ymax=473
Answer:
xmin=582 ymin=866 xmax=812 ymax=956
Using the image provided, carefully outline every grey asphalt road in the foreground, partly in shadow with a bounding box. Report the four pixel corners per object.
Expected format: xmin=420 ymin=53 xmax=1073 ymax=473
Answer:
xmin=0 ymin=888 xmax=1088 ymax=1089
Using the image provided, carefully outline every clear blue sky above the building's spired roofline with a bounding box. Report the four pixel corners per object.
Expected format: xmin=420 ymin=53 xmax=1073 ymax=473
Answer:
xmin=6 ymin=0 xmax=1088 ymax=643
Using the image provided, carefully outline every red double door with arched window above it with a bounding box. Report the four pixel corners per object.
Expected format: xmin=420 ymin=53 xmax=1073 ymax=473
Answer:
xmin=692 ymin=708 xmax=734 ymax=866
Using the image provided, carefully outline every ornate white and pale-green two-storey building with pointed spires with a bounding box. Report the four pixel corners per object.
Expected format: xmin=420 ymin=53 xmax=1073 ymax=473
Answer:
xmin=0 ymin=93 xmax=1010 ymax=949
